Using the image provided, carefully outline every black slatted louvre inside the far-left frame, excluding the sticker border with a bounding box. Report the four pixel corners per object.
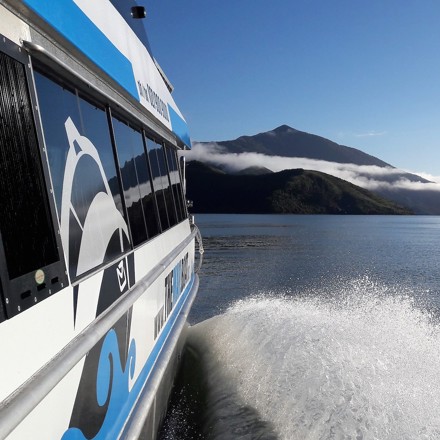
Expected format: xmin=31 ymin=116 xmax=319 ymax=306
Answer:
xmin=0 ymin=53 xmax=59 ymax=279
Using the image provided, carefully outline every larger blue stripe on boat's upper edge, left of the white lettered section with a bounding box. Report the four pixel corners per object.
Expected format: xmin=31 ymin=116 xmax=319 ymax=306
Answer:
xmin=24 ymin=0 xmax=139 ymax=100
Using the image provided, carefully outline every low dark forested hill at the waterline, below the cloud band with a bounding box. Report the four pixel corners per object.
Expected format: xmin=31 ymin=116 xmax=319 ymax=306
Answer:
xmin=186 ymin=161 xmax=412 ymax=214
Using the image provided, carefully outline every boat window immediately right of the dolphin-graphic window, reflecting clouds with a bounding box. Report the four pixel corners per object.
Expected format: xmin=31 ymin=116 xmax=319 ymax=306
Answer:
xmin=112 ymin=118 xmax=159 ymax=246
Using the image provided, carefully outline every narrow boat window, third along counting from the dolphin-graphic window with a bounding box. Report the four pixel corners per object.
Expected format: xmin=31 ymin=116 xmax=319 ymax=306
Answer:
xmin=147 ymin=138 xmax=177 ymax=229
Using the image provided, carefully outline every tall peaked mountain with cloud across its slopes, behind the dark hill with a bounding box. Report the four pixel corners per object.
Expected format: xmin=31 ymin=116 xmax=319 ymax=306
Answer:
xmin=194 ymin=125 xmax=440 ymax=215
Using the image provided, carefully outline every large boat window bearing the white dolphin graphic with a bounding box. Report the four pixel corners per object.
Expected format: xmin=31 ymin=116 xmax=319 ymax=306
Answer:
xmin=35 ymin=73 xmax=130 ymax=278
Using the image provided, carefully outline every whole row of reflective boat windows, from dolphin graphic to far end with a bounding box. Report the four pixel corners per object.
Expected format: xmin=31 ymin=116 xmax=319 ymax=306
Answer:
xmin=35 ymin=72 xmax=187 ymax=278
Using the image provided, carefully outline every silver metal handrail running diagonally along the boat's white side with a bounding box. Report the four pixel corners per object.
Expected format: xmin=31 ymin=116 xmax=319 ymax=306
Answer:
xmin=0 ymin=225 xmax=200 ymax=439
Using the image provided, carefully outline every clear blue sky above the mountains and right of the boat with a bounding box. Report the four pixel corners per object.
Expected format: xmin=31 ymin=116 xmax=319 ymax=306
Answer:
xmin=145 ymin=0 xmax=440 ymax=176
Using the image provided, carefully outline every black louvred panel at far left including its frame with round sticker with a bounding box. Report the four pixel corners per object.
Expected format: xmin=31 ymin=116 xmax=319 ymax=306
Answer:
xmin=0 ymin=43 xmax=65 ymax=318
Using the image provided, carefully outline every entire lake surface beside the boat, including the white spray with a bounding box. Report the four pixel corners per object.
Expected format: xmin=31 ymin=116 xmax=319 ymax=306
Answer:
xmin=161 ymin=215 xmax=440 ymax=440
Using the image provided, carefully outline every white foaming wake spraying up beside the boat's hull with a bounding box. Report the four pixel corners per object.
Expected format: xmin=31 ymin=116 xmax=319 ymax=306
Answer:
xmin=160 ymin=278 xmax=440 ymax=440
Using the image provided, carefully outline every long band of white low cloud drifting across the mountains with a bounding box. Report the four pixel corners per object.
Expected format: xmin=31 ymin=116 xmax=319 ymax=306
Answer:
xmin=185 ymin=143 xmax=440 ymax=191
